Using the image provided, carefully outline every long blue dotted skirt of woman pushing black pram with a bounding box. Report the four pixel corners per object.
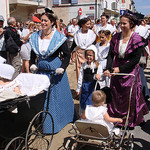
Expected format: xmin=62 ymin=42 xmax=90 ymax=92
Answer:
xmin=38 ymin=57 xmax=75 ymax=134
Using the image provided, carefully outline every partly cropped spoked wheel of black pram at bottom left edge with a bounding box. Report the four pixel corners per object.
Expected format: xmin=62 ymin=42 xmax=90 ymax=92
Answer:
xmin=5 ymin=137 xmax=25 ymax=150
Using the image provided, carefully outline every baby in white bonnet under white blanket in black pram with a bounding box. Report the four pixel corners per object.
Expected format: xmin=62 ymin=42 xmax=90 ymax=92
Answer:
xmin=0 ymin=64 xmax=50 ymax=102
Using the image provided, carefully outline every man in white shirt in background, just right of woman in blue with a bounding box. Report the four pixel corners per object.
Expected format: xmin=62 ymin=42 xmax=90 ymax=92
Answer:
xmin=68 ymin=18 xmax=79 ymax=48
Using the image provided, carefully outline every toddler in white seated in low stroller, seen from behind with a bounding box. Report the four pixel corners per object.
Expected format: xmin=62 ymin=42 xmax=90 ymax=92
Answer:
xmin=81 ymin=90 xmax=122 ymax=133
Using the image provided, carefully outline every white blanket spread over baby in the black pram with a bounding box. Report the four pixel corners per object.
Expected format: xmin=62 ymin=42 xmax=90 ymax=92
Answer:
xmin=0 ymin=73 xmax=50 ymax=102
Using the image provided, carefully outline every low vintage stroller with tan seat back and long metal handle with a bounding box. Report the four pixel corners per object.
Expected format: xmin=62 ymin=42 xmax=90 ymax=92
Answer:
xmin=65 ymin=73 xmax=135 ymax=150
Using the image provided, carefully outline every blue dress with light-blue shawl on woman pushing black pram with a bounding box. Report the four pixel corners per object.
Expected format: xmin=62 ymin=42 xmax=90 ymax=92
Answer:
xmin=30 ymin=30 xmax=74 ymax=133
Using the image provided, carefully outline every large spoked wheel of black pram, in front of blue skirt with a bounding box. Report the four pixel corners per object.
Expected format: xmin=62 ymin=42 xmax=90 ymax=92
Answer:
xmin=25 ymin=111 xmax=54 ymax=150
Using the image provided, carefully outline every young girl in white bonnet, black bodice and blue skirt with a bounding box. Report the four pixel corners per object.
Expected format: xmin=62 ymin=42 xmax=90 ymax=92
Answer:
xmin=76 ymin=45 xmax=103 ymax=111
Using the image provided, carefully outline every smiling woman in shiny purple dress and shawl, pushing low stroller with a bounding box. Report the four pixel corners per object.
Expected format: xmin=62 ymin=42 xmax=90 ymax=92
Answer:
xmin=104 ymin=14 xmax=148 ymax=127
